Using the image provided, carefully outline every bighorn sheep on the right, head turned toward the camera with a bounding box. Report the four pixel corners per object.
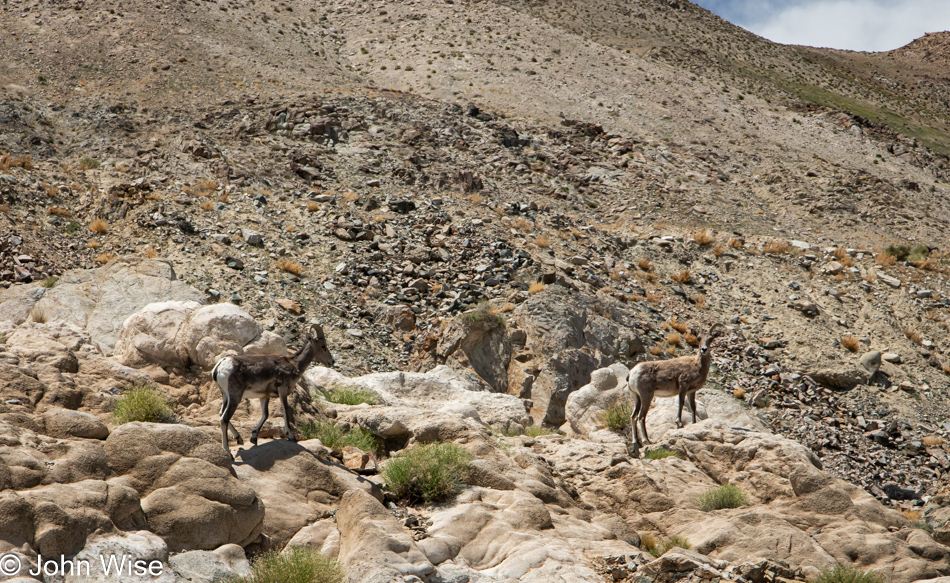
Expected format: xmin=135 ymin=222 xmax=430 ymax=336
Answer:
xmin=627 ymin=324 xmax=725 ymax=449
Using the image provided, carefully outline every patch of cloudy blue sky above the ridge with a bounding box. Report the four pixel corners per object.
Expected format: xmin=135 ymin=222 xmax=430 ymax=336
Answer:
xmin=693 ymin=0 xmax=950 ymax=51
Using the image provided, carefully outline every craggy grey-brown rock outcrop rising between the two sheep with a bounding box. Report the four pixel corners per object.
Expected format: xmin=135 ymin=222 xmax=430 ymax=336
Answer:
xmin=410 ymin=285 xmax=644 ymax=427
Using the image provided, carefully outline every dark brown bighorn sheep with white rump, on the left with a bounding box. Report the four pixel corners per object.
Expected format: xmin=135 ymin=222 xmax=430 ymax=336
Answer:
xmin=211 ymin=324 xmax=333 ymax=459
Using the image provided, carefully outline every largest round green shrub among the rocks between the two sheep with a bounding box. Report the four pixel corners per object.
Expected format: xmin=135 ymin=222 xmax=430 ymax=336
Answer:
xmin=382 ymin=443 xmax=472 ymax=504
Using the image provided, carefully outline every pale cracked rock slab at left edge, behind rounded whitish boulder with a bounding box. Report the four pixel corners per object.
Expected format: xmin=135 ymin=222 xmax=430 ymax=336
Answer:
xmin=0 ymin=255 xmax=205 ymax=354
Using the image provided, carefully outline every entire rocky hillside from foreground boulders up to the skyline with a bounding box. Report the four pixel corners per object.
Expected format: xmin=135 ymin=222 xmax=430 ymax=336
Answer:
xmin=0 ymin=0 xmax=950 ymax=581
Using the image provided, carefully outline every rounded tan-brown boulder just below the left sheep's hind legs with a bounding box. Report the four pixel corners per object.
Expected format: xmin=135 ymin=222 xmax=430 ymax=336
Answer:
xmin=105 ymin=423 xmax=264 ymax=551
